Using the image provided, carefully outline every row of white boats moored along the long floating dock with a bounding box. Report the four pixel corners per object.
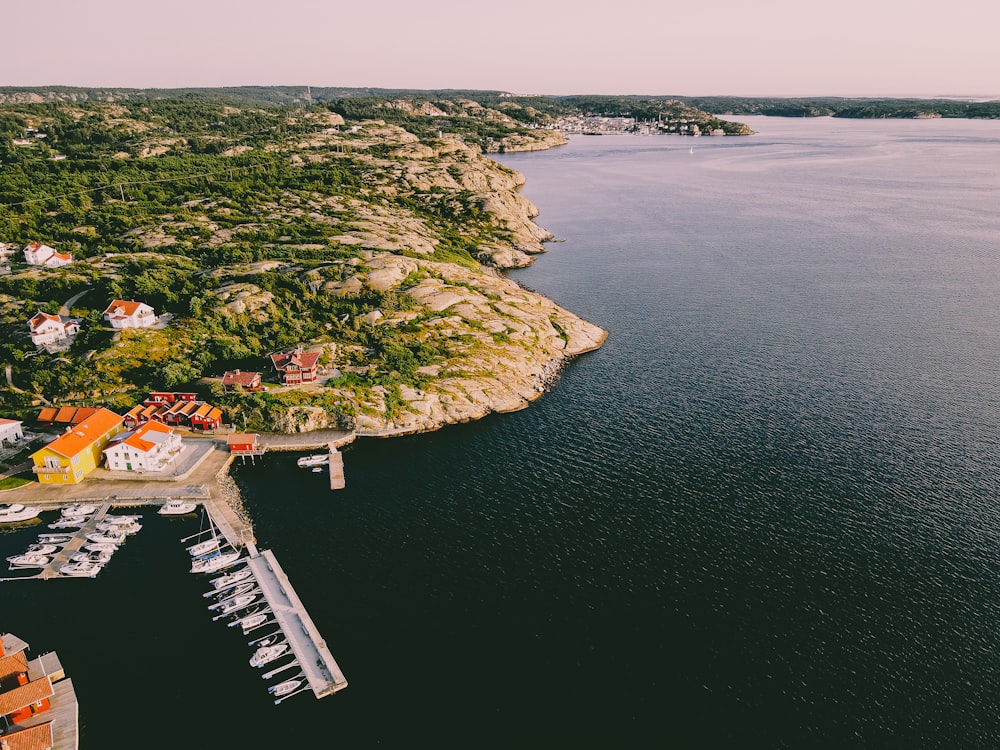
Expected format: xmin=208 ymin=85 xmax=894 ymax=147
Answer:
xmin=187 ymin=528 xmax=309 ymax=704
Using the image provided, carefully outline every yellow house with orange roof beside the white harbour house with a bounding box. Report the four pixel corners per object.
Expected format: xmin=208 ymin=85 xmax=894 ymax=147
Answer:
xmin=31 ymin=409 xmax=125 ymax=484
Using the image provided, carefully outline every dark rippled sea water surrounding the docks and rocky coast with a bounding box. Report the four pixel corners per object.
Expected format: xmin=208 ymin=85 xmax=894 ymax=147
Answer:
xmin=0 ymin=119 xmax=1000 ymax=748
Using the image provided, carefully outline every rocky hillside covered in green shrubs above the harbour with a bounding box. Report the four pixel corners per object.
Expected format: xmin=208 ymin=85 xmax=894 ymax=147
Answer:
xmin=0 ymin=93 xmax=604 ymax=431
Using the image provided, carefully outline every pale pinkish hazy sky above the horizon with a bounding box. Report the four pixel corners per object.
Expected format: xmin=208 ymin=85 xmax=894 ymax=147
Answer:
xmin=0 ymin=0 xmax=1000 ymax=98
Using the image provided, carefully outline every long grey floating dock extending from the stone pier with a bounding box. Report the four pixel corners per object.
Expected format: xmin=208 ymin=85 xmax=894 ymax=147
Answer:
xmin=247 ymin=542 xmax=347 ymax=698
